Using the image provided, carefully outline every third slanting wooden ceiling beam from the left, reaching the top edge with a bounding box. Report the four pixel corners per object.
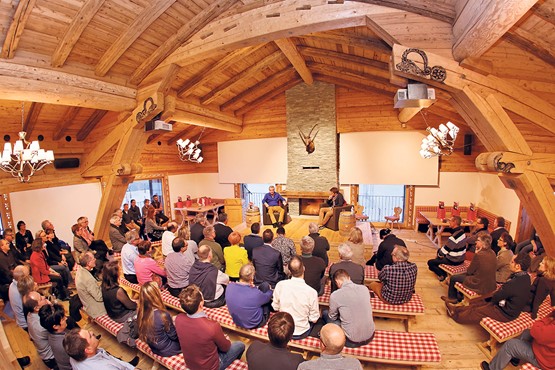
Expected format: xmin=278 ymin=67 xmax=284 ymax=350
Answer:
xmin=95 ymin=0 xmax=176 ymax=76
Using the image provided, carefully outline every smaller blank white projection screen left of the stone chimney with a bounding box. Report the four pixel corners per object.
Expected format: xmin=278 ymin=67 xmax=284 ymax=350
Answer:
xmin=218 ymin=137 xmax=287 ymax=184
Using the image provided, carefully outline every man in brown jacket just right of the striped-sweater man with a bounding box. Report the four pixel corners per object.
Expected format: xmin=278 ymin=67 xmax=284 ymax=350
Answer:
xmin=441 ymin=233 xmax=498 ymax=303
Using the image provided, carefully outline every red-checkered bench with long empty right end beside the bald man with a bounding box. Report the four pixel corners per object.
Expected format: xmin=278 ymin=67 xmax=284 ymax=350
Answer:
xmin=204 ymin=306 xmax=441 ymax=367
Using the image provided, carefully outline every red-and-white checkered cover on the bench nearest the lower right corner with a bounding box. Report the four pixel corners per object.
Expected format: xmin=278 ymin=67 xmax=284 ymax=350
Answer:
xmin=480 ymin=296 xmax=553 ymax=342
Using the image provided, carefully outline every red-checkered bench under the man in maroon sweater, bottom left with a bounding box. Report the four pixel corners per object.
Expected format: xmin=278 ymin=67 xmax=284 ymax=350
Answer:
xmin=92 ymin=315 xmax=248 ymax=370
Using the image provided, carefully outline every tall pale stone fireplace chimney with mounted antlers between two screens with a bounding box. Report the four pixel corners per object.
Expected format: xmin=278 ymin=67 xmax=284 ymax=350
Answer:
xmin=283 ymin=82 xmax=338 ymax=215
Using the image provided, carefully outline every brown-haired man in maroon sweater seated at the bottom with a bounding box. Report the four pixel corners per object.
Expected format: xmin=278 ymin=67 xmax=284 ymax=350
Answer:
xmin=175 ymin=284 xmax=245 ymax=370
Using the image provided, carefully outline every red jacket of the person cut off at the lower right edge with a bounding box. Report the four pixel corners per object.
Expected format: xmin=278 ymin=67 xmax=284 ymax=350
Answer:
xmin=530 ymin=312 xmax=555 ymax=370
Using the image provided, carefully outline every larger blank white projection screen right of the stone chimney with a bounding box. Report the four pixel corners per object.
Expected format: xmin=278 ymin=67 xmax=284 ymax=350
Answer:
xmin=339 ymin=131 xmax=439 ymax=185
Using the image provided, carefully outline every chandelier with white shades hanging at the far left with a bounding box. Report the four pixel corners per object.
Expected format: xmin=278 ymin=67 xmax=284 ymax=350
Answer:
xmin=0 ymin=103 xmax=54 ymax=182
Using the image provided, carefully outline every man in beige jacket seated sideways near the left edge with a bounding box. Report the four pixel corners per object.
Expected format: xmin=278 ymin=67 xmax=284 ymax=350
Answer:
xmin=75 ymin=252 xmax=106 ymax=319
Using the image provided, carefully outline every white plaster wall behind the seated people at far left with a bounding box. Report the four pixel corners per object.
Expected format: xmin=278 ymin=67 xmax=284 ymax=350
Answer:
xmin=10 ymin=183 xmax=102 ymax=246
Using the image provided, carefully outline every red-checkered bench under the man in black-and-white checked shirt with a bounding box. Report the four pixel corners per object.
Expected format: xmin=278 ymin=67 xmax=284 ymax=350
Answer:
xmin=318 ymin=285 xmax=424 ymax=332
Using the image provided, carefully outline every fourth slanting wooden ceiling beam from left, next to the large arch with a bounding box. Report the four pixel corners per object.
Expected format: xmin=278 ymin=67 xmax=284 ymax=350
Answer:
xmin=130 ymin=0 xmax=237 ymax=84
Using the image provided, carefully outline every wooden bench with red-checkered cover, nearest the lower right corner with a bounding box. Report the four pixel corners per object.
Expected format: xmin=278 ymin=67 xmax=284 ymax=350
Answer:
xmin=478 ymin=296 xmax=552 ymax=359
